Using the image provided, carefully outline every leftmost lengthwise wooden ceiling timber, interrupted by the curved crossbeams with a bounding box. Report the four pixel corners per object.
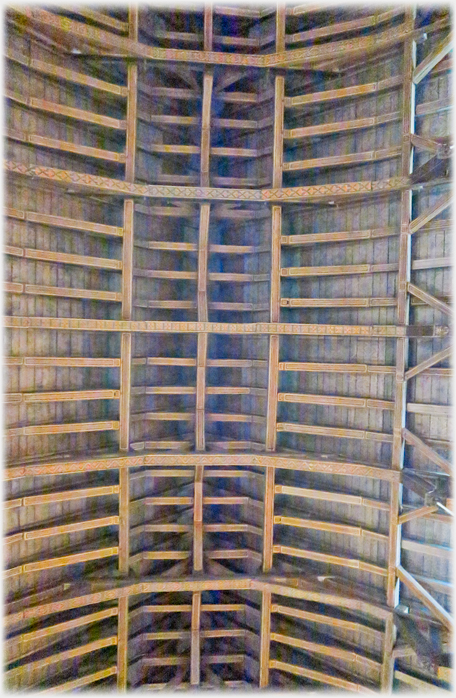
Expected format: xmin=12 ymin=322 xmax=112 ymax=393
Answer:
xmin=117 ymin=5 xmax=138 ymax=691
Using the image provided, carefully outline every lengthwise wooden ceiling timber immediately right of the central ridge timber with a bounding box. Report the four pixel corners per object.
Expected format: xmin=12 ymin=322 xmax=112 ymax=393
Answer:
xmin=259 ymin=4 xmax=286 ymax=688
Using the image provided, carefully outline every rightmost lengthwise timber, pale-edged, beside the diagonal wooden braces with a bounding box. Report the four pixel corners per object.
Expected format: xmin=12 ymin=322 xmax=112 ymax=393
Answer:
xmin=381 ymin=8 xmax=416 ymax=692
